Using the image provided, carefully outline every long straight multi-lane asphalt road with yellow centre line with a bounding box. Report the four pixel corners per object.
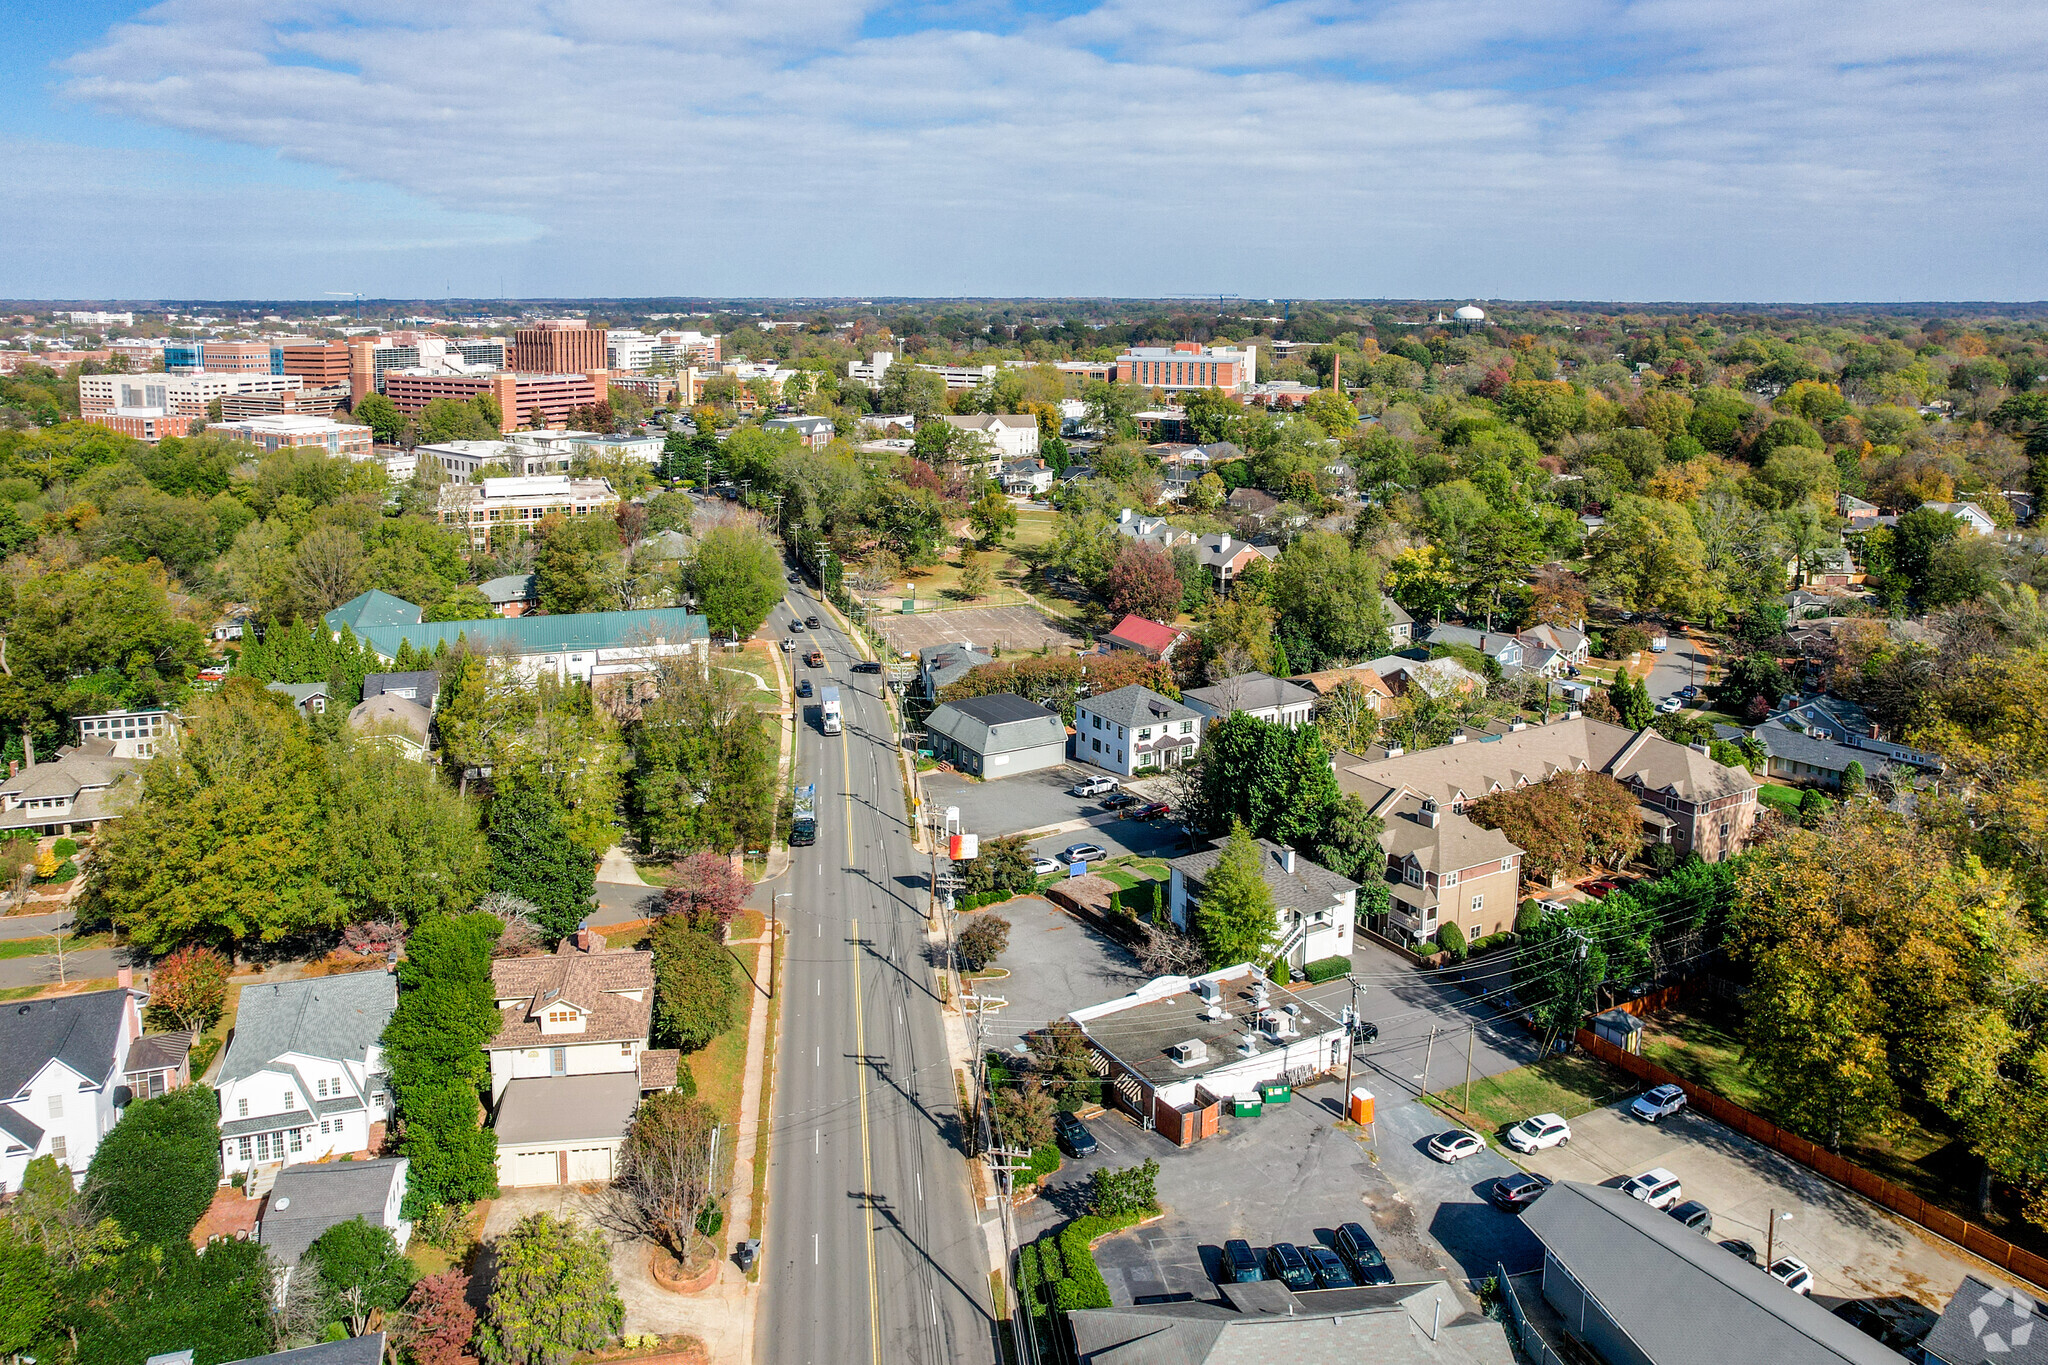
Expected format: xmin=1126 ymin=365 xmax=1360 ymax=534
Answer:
xmin=758 ymin=589 xmax=995 ymax=1365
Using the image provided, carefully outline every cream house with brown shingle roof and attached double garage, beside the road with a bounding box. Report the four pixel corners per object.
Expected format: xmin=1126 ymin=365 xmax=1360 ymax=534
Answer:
xmin=483 ymin=929 xmax=680 ymax=1185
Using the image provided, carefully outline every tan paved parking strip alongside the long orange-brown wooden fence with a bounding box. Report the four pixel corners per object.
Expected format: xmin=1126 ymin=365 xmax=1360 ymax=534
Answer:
xmin=1524 ymin=1103 xmax=1982 ymax=1312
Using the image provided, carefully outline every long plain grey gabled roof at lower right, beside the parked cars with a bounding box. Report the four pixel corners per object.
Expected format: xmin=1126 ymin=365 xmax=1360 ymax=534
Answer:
xmin=1522 ymin=1181 xmax=1898 ymax=1365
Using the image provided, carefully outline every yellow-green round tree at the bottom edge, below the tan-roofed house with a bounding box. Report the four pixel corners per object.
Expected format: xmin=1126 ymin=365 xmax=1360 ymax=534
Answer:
xmin=477 ymin=1214 xmax=625 ymax=1365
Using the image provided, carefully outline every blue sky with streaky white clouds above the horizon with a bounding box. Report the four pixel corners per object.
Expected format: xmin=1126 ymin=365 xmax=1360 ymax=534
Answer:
xmin=0 ymin=0 xmax=2048 ymax=301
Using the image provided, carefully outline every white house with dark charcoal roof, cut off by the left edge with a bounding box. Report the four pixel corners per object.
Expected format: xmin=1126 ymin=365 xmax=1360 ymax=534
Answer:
xmin=0 ymin=968 xmax=141 ymax=1195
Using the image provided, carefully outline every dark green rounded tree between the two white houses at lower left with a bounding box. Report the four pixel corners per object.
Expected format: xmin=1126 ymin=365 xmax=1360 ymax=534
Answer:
xmin=84 ymin=1085 xmax=221 ymax=1246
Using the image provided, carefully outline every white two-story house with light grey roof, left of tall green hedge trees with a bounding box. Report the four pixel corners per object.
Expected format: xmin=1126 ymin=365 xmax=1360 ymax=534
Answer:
xmin=213 ymin=972 xmax=397 ymax=1175
